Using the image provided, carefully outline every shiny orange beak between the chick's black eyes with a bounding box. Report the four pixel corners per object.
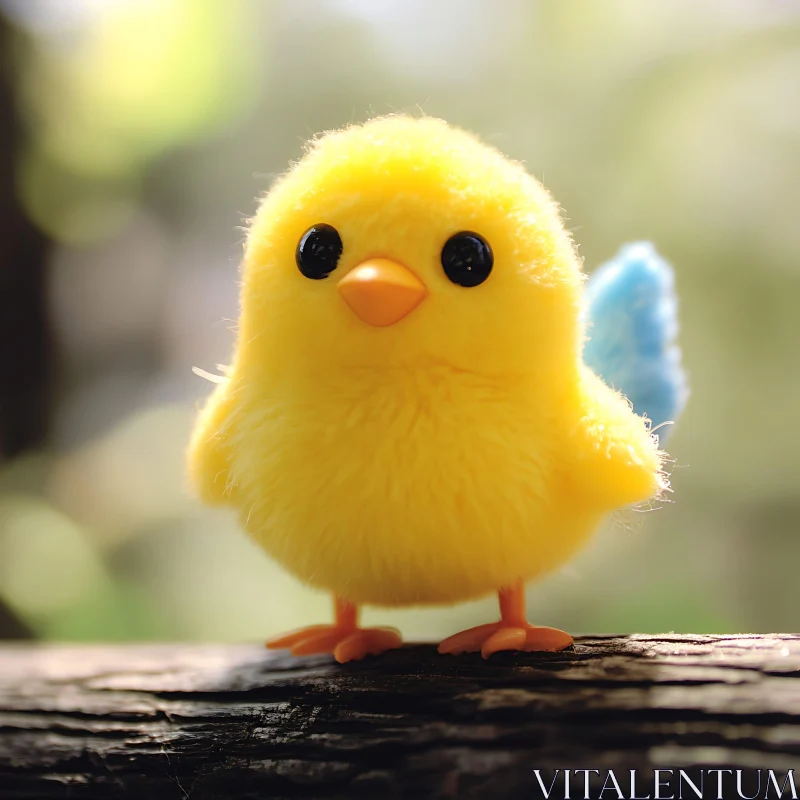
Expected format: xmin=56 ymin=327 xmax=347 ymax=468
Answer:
xmin=337 ymin=258 xmax=428 ymax=328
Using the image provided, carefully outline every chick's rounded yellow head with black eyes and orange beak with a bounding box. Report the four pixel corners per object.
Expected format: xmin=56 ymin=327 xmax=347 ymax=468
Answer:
xmin=239 ymin=116 xmax=582 ymax=384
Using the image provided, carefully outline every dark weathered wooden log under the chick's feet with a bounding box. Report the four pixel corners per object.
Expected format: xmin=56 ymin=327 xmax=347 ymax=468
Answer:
xmin=0 ymin=634 xmax=800 ymax=800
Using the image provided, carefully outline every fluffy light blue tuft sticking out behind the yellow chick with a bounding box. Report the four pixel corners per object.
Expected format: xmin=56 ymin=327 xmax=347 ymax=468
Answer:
xmin=583 ymin=242 xmax=689 ymax=445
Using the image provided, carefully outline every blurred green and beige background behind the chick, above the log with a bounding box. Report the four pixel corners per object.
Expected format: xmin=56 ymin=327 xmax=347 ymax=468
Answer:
xmin=0 ymin=0 xmax=800 ymax=640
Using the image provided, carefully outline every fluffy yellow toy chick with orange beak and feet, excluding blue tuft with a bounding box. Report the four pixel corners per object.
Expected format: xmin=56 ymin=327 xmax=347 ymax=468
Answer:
xmin=189 ymin=116 xmax=666 ymax=662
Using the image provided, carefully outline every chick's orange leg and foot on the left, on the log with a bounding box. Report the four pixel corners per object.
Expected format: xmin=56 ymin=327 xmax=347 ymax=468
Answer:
xmin=267 ymin=597 xmax=403 ymax=664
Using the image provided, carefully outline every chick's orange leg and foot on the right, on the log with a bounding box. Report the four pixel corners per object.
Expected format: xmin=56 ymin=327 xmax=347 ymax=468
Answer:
xmin=439 ymin=581 xmax=572 ymax=658
